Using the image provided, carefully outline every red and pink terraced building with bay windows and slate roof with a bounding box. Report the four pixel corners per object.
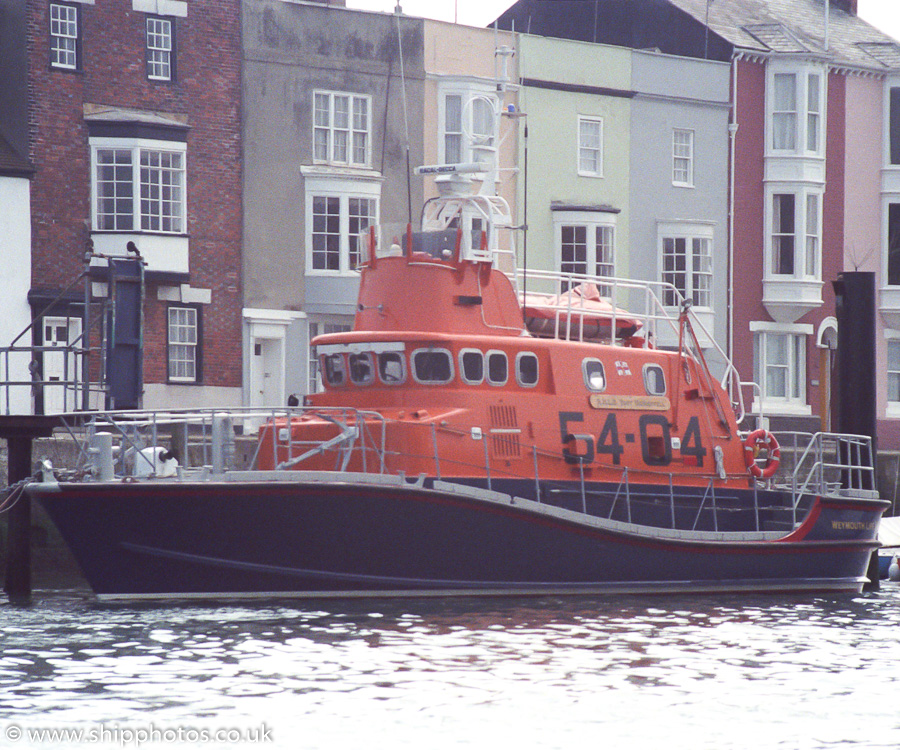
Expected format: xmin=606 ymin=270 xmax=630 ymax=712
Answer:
xmin=499 ymin=0 xmax=900 ymax=458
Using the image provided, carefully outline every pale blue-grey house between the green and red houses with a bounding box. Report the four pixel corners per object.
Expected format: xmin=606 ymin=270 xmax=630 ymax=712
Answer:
xmin=628 ymin=51 xmax=730 ymax=356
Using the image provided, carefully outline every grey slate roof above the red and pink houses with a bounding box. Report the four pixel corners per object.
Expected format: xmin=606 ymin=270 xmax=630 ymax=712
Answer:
xmin=668 ymin=0 xmax=900 ymax=71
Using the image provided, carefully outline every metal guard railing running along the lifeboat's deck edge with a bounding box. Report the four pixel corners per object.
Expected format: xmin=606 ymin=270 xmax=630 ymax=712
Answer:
xmin=28 ymin=407 xmax=874 ymax=533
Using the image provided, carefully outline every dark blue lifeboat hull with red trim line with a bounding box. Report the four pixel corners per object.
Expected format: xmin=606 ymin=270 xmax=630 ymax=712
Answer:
xmin=31 ymin=482 xmax=885 ymax=598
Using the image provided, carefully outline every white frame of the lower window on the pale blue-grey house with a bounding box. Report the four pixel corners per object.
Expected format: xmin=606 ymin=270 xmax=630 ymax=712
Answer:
xmin=657 ymin=222 xmax=715 ymax=312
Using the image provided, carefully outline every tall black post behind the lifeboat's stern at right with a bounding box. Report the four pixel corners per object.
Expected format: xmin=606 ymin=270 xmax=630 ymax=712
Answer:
xmin=833 ymin=271 xmax=879 ymax=589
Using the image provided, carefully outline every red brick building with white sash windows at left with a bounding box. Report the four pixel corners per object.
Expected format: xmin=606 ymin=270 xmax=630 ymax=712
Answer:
xmin=26 ymin=0 xmax=242 ymax=411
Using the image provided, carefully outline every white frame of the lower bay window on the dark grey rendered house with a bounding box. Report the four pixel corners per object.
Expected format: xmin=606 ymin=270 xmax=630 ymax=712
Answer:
xmin=305 ymin=175 xmax=381 ymax=276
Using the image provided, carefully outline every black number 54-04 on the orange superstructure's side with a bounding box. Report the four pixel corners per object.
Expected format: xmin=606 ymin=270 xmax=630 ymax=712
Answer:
xmin=559 ymin=411 xmax=706 ymax=466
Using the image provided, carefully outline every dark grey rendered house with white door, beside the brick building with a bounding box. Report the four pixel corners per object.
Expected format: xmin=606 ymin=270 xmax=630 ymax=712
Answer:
xmin=243 ymin=0 xmax=425 ymax=406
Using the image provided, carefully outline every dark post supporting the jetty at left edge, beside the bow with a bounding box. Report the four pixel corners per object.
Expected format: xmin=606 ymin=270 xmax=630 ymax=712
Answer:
xmin=4 ymin=435 xmax=31 ymax=604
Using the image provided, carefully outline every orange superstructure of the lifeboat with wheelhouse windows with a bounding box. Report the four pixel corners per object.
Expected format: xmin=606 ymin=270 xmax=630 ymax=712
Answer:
xmin=261 ymin=217 xmax=748 ymax=488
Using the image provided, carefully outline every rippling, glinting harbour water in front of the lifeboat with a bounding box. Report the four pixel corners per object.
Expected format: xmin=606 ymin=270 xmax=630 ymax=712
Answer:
xmin=0 ymin=584 xmax=900 ymax=750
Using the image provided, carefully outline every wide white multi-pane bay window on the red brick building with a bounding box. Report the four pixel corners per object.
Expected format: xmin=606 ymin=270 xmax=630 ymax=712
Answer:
xmin=92 ymin=145 xmax=186 ymax=234
